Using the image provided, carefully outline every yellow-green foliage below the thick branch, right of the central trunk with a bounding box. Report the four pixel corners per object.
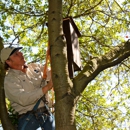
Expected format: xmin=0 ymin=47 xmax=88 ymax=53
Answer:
xmin=76 ymin=63 xmax=130 ymax=130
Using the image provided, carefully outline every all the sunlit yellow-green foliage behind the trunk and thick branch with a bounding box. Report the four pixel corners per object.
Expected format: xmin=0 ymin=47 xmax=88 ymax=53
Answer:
xmin=0 ymin=0 xmax=130 ymax=130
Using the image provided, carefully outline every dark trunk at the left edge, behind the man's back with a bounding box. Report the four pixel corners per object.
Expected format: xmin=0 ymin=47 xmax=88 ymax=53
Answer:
xmin=0 ymin=37 xmax=15 ymax=130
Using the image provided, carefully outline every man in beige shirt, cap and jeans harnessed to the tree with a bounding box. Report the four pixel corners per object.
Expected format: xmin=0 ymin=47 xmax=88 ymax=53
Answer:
xmin=0 ymin=47 xmax=55 ymax=130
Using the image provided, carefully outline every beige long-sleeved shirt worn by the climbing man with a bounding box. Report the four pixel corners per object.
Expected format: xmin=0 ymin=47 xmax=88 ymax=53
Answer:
xmin=4 ymin=63 xmax=50 ymax=114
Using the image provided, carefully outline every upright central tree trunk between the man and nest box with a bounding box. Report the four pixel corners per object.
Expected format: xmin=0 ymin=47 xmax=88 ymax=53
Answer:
xmin=48 ymin=0 xmax=76 ymax=130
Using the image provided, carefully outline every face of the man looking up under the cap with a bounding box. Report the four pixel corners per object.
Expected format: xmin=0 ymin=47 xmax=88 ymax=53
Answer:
xmin=6 ymin=50 xmax=25 ymax=68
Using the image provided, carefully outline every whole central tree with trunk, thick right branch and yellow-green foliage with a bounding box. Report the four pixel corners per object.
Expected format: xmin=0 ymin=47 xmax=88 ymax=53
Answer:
xmin=0 ymin=0 xmax=130 ymax=130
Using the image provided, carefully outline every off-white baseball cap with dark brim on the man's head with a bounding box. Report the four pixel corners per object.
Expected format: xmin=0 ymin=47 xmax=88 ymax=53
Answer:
xmin=0 ymin=46 xmax=23 ymax=64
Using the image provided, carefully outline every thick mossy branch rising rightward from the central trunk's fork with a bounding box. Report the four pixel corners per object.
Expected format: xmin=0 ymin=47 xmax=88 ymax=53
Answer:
xmin=73 ymin=40 xmax=130 ymax=96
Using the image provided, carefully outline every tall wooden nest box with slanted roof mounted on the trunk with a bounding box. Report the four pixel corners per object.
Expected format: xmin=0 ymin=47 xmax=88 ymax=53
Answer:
xmin=63 ymin=17 xmax=81 ymax=78
